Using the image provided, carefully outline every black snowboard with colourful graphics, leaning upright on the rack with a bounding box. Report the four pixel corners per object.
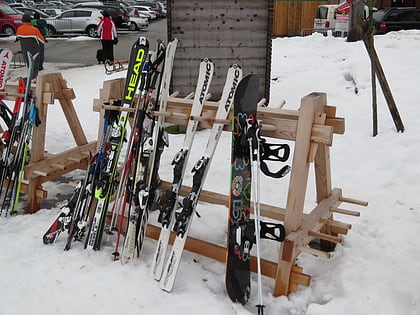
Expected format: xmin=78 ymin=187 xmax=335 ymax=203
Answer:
xmin=225 ymin=74 xmax=259 ymax=304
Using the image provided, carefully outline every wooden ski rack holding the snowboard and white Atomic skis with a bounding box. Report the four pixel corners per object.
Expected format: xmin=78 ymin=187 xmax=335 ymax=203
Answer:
xmin=93 ymin=80 xmax=367 ymax=296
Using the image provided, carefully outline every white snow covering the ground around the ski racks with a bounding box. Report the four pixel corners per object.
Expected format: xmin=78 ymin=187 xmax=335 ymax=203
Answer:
xmin=0 ymin=31 xmax=420 ymax=315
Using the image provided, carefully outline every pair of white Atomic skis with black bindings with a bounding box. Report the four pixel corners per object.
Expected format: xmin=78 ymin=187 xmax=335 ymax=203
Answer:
xmin=152 ymin=59 xmax=242 ymax=291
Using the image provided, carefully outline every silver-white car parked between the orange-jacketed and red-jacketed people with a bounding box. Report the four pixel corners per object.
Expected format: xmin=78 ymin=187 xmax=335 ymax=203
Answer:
xmin=45 ymin=8 xmax=102 ymax=37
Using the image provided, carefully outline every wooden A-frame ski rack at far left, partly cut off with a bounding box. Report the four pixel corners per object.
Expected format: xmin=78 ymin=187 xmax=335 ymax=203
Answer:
xmin=3 ymin=73 xmax=97 ymax=213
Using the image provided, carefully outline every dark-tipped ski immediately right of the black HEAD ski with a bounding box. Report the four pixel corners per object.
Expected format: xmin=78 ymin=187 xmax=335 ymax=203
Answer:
xmin=121 ymin=41 xmax=166 ymax=264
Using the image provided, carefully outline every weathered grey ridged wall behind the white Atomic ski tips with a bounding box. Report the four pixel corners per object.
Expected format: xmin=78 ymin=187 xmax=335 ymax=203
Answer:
xmin=168 ymin=0 xmax=272 ymax=100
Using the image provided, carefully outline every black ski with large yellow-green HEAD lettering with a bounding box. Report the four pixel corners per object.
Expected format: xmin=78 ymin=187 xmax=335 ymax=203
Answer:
xmin=85 ymin=37 xmax=149 ymax=250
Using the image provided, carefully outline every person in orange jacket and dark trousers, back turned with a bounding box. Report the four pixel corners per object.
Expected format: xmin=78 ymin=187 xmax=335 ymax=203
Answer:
xmin=16 ymin=14 xmax=46 ymax=78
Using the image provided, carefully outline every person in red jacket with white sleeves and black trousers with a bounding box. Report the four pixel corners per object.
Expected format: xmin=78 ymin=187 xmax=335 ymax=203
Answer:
xmin=96 ymin=11 xmax=118 ymax=61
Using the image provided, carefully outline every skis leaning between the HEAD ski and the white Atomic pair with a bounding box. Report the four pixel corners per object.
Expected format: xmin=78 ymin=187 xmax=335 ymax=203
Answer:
xmin=113 ymin=39 xmax=178 ymax=264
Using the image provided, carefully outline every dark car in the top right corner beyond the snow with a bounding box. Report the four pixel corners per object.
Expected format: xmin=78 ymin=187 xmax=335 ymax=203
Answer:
xmin=373 ymin=7 xmax=420 ymax=34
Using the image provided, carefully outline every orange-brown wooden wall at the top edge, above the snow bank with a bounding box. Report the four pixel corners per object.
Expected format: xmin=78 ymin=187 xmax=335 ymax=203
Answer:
xmin=273 ymin=0 xmax=342 ymax=36
